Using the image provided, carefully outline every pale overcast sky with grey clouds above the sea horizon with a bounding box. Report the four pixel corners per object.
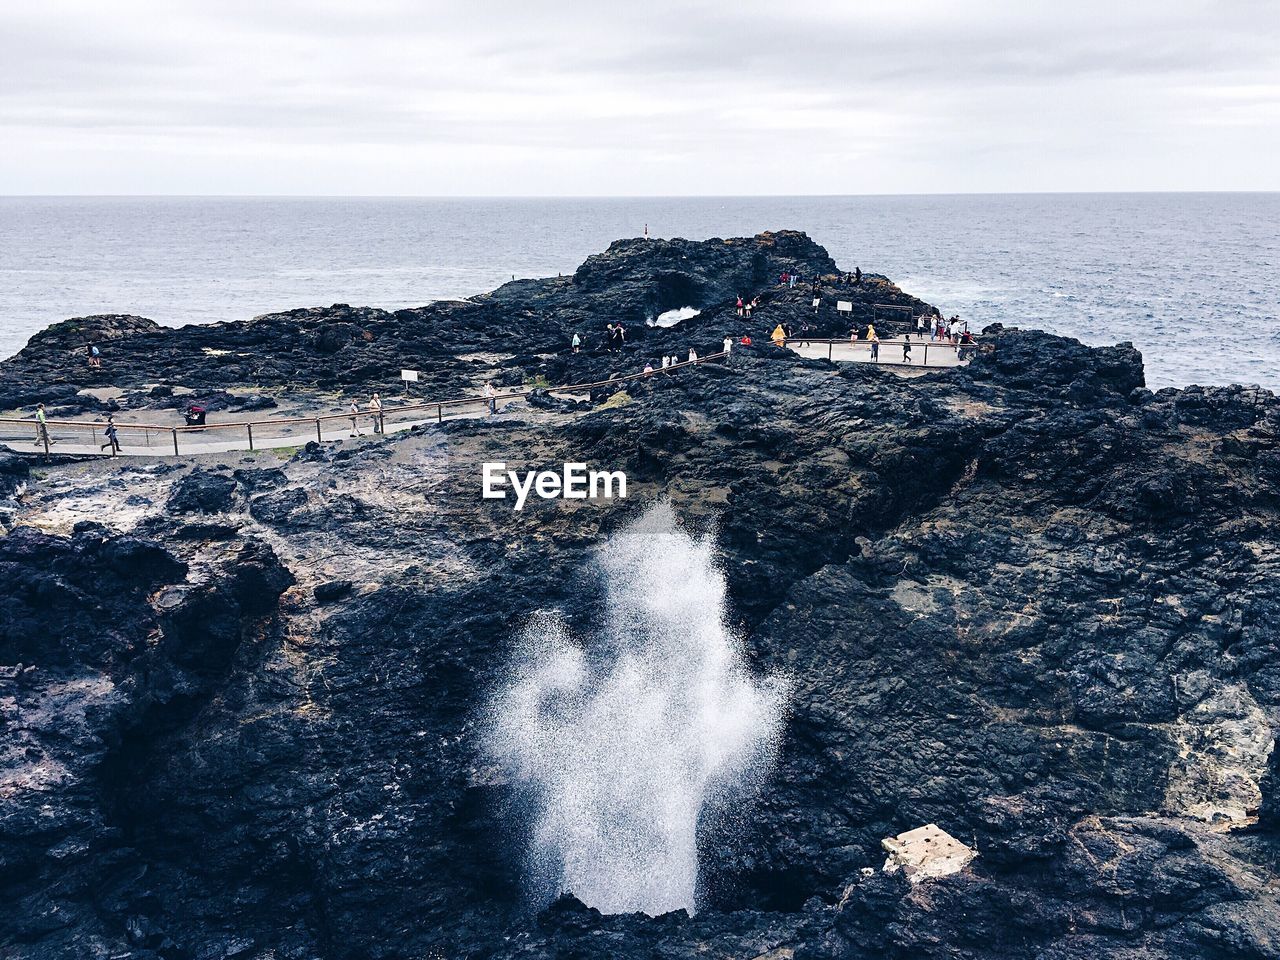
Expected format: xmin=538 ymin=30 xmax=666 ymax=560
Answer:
xmin=0 ymin=0 xmax=1280 ymax=196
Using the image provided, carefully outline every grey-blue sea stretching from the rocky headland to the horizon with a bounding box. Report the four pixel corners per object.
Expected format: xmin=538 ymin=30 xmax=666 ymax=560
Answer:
xmin=0 ymin=193 xmax=1280 ymax=390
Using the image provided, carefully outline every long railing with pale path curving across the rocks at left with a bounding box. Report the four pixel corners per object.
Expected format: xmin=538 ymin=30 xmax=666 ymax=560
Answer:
xmin=0 ymin=352 xmax=728 ymax=457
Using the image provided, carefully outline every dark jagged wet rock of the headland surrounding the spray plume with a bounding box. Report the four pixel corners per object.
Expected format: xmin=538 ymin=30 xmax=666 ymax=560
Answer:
xmin=0 ymin=234 xmax=1280 ymax=960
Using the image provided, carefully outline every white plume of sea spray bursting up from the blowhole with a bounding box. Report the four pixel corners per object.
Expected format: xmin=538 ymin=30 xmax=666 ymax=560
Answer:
xmin=489 ymin=503 xmax=785 ymax=915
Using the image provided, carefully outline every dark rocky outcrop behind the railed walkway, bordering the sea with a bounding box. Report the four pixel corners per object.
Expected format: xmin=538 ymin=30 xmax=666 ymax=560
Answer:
xmin=0 ymin=230 xmax=929 ymax=415
